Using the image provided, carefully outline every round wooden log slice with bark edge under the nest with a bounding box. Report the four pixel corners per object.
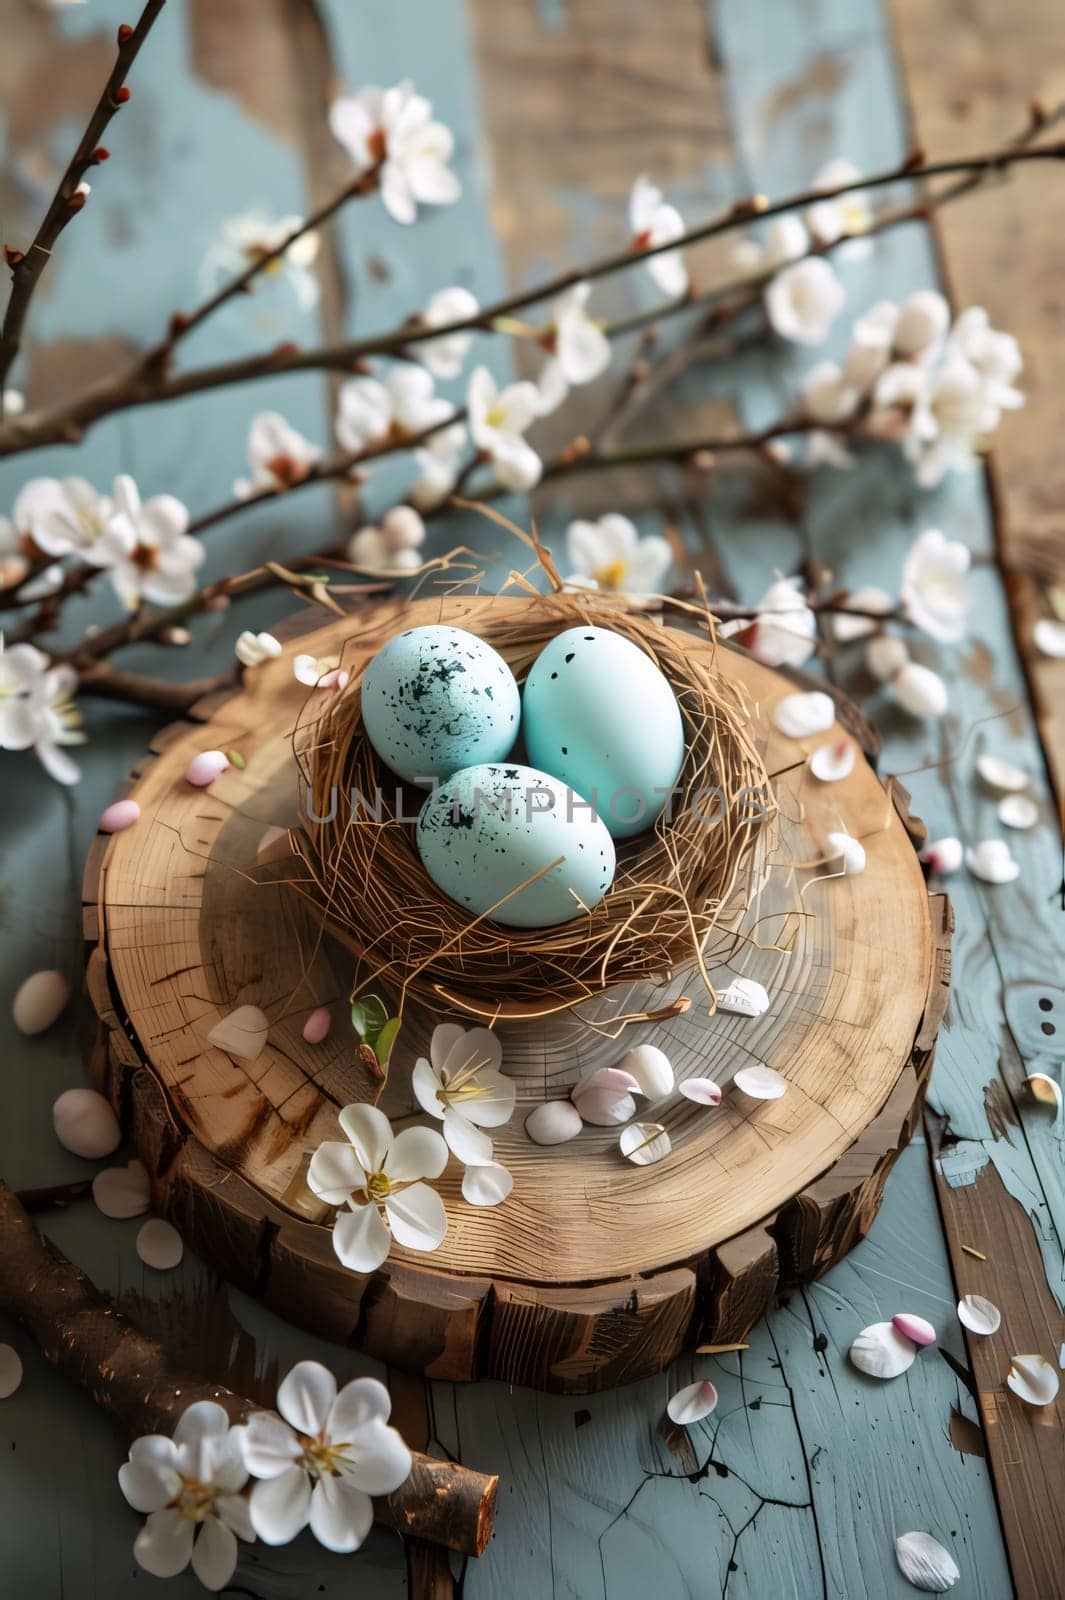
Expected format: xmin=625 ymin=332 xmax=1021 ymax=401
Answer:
xmin=85 ymin=598 xmax=950 ymax=1392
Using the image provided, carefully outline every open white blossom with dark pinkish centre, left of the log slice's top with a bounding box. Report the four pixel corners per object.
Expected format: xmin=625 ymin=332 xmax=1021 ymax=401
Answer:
xmin=99 ymin=474 xmax=206 ymax=611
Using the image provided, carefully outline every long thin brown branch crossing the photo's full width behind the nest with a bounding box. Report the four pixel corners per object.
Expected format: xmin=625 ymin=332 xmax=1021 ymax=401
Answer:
xmin=0 ymin=123 xmax=1065 ymax=456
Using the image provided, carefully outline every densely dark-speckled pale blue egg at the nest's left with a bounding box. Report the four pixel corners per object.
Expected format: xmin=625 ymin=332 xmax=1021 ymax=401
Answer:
xmin=363 ymin=626 xmax=521 ymax=789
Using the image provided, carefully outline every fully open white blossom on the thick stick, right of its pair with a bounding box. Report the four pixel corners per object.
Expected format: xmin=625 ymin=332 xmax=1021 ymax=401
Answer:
xmin=243 ymin=1362 xmax=413 ymax=1552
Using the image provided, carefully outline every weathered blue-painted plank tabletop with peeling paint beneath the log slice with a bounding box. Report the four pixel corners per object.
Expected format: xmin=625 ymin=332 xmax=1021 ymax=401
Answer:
xmin=0 ymin=0 xmax=1042 ymax=1600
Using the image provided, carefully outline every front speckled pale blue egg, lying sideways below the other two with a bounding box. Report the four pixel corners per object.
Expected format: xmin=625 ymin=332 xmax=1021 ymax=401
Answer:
xmin=417 ymin=763 xmax=614 ymax=928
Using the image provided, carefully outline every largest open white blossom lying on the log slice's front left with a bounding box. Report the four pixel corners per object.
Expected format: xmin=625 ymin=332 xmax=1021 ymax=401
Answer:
xmin=307 ymin=1106 xmax=448 ymax=1272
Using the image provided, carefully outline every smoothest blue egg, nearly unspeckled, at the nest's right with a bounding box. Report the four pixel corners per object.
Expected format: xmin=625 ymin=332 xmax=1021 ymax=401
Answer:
xmin=521 ymin=627 xmax=684 ymax=838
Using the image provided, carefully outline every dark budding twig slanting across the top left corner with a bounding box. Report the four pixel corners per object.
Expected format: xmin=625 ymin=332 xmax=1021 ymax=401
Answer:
xmin=0 ymin=0 xmax=166 ymax=395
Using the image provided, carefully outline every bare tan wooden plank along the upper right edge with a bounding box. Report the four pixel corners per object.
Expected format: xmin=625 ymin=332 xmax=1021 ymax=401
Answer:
xmin=891 ymin=0 xmax=1065 ymax=803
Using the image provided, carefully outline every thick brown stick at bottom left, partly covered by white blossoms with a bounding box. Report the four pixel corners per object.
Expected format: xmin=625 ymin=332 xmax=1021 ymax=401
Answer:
xmin=0 ymin=1179 xmax=499 ymax=1555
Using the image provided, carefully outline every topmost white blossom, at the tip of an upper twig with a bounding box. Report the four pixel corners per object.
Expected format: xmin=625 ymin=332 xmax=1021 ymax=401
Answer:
xmin=329 ymin=83 xmax=462 ymax=222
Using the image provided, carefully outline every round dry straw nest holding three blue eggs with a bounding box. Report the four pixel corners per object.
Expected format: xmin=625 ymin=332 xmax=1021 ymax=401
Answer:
xmin=293 ymin=594 xmax=772 ymax=1021
